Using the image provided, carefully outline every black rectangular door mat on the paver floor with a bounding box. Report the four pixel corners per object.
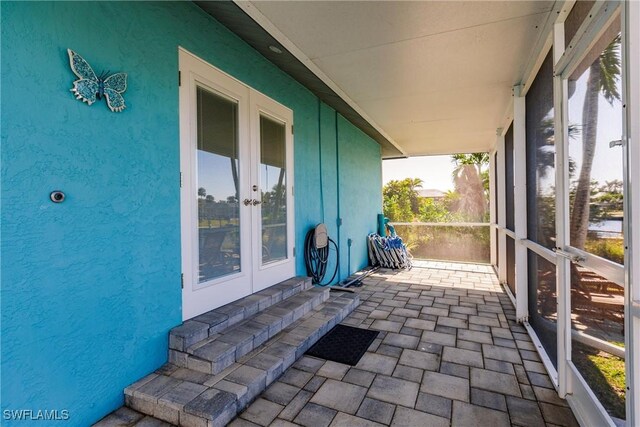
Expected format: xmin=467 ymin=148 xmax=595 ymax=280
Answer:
xmin=307 ymin=325 xmax=378 ymax=366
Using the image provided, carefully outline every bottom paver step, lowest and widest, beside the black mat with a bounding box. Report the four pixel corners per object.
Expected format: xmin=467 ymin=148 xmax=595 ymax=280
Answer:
xmin=125 ymin=295 xmax=359 ymax=427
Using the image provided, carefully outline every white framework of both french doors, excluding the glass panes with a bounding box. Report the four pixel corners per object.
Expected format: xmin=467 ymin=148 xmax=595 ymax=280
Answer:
xmin=178 ymin=48 xmax=295 ymax=320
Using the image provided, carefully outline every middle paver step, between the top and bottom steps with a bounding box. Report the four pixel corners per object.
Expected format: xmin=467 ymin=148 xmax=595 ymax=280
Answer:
xmin=169 ymin=289 xmax=329 ymax=375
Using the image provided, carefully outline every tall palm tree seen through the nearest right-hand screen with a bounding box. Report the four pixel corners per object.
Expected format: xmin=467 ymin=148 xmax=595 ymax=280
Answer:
xmin=570 ymin=35 xmax=620 ymax=249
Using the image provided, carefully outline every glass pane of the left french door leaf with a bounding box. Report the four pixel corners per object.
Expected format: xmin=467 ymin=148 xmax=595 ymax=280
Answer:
xmin=196 ymin=87 xmax=241 ymax=283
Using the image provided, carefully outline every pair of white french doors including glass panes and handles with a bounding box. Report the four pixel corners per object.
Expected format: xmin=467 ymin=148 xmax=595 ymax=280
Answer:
xmin=179 ymin=49 xmax=295 ymax=319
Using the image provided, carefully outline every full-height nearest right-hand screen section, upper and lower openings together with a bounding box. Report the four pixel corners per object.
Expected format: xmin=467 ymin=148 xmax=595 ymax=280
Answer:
xmin=568 ymin=17 xmax=626 ymax=419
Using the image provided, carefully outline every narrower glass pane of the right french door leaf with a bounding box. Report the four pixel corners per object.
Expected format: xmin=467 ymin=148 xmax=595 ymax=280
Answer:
xmin=260 ymin=115 xmax=287 ymax=265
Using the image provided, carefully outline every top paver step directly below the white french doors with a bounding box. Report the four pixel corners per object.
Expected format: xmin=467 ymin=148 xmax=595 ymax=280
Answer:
xmin=169 ymin=277 xmax=313 ymax=351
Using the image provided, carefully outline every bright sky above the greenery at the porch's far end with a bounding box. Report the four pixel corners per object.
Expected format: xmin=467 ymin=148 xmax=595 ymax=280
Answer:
xmin=382 ymin=156 xmax=455 ymax=192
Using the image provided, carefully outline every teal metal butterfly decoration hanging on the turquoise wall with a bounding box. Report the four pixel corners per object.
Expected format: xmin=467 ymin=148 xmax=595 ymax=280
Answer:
xmin=67 ymin=49 xmax=127 ymax=113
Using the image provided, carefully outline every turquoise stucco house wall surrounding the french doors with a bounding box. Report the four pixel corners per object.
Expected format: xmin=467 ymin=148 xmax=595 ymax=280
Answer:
xmin=0 ymin=2 xmax=382 ymax=425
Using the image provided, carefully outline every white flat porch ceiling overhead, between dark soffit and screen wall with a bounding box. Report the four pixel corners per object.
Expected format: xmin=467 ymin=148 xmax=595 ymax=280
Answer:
xmin=245 ymin=1 xmax=554 ymax=156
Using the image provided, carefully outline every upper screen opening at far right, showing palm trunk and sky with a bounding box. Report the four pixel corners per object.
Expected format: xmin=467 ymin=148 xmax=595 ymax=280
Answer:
xmin=567 ymin=19 xmax=624 ymax=264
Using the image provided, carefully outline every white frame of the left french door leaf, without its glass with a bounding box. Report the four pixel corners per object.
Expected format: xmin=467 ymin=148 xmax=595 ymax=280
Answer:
xmin=179 ymin=49 xmax=251 ymax=320
